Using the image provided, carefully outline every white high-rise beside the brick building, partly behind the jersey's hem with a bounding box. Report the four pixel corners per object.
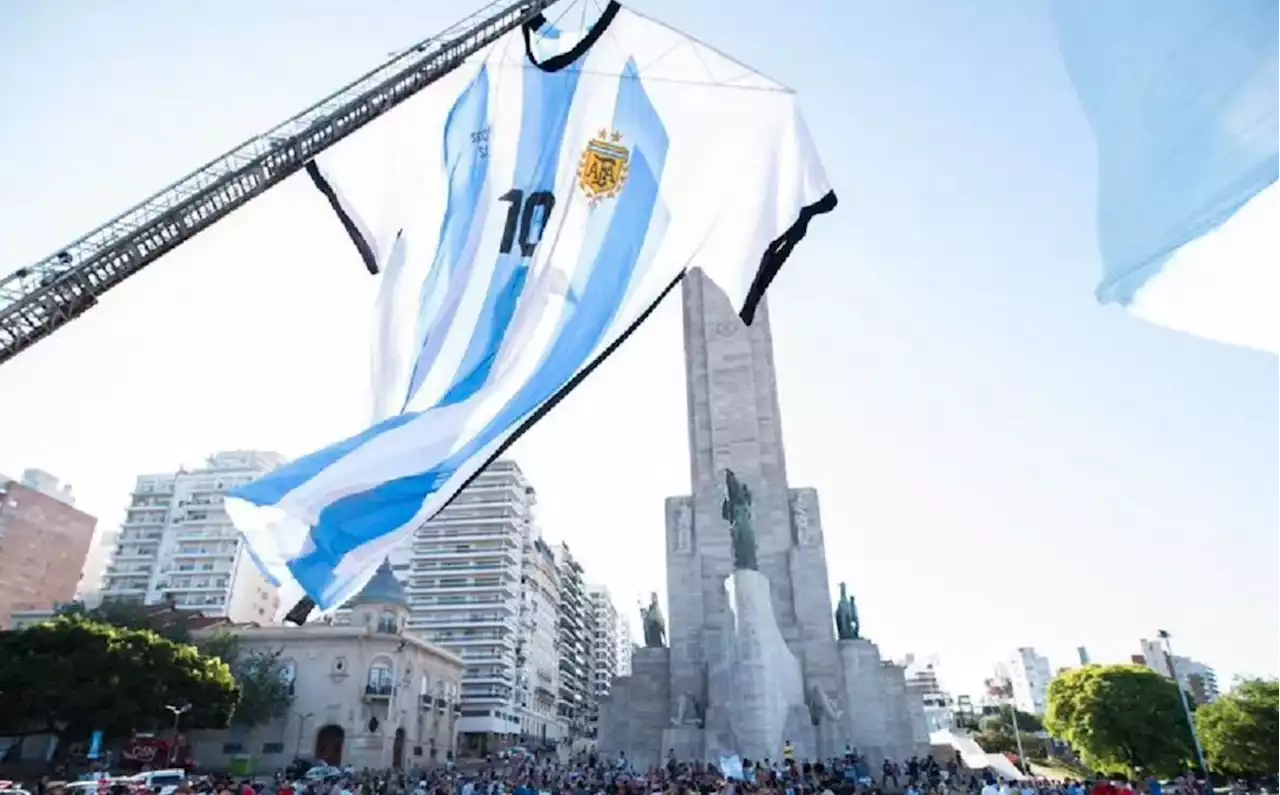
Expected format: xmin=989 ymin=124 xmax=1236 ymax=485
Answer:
xmin=102 ymin=451 xmax=285 ymax=625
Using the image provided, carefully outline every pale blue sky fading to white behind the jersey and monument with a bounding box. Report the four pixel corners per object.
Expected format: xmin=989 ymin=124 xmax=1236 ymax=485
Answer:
xmin=0 ymin=0 xmax=1280 ymax=691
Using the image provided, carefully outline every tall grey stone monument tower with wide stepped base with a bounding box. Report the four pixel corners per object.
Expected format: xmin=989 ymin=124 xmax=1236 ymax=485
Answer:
xmin=599 ymin=271 xmax=928 ymax=767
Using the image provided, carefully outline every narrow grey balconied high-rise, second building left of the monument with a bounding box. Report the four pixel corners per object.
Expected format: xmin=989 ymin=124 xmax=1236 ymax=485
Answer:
xmin=556 ymin=543 xmax=591 ymax=736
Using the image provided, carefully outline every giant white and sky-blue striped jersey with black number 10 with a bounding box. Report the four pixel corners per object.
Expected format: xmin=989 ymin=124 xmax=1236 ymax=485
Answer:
xmin=227 ymin=3 xmax=836 ymax=609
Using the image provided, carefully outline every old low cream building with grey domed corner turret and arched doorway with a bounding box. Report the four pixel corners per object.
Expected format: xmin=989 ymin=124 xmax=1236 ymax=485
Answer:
xmin=192 ymin=563 xmax=465 ymax=772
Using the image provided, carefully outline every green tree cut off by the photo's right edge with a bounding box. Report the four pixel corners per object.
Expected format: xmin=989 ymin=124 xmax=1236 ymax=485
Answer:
xmin=1196 ymin=679 xmax=1280 ymax=776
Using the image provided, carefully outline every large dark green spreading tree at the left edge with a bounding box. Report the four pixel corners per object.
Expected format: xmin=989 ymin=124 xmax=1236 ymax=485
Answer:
xmin=0 ymin=614 xmax=239 ymax=741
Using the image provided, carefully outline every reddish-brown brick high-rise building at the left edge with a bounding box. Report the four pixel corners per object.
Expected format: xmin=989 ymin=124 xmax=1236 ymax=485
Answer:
xmin=0 ymin=470 xmax=97 ymax=627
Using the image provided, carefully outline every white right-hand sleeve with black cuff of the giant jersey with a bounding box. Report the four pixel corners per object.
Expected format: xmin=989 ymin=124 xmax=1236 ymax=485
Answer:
xmin=691 ymin=92 xmax=836 ymax=324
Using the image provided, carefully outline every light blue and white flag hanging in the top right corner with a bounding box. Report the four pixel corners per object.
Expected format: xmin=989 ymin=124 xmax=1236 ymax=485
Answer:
xmin=1053 ymin=0 xmax=1280 ymax=353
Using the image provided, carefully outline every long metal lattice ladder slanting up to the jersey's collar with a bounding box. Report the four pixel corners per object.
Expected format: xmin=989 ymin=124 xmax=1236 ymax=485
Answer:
xmin=0 ymin=0 xmax=558 ymax=364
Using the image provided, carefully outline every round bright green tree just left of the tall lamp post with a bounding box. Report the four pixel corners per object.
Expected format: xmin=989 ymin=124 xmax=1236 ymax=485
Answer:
xmin=1044 ymin=666 xmax=1196 ymax=776
